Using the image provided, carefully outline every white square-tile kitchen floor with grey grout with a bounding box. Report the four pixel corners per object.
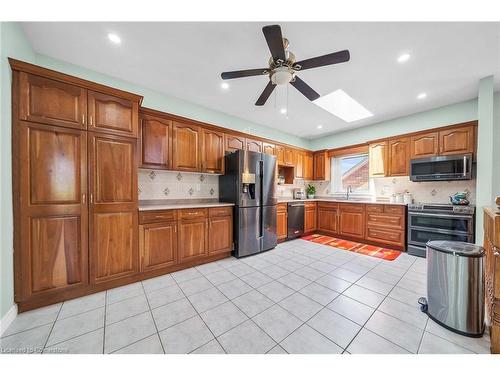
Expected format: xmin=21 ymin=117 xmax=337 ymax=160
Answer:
xmin=0 ymin=240 xmax=490 ymax=354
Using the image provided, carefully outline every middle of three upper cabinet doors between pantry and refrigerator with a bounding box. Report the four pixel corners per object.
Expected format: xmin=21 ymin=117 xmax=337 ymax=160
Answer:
xmin=172 ymin=121 xmax=201 ymax=172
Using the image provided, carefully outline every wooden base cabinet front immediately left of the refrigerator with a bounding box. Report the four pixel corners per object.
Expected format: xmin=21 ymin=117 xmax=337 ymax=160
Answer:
xmin=208 ymin=207 xmax=233 ymax=255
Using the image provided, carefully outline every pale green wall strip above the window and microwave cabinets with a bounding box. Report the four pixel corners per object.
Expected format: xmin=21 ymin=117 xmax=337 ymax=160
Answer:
xmin=311 ymin=99 xmax=477 ymax=150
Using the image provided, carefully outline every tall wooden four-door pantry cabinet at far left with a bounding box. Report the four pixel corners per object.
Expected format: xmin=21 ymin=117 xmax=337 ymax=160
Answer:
xmin=10 ymin=59 xmax=142 ymax=311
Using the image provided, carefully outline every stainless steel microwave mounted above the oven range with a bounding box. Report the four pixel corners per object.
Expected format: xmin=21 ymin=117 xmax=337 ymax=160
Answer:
xmin=410 ymin=154 xmax=472 ymax=181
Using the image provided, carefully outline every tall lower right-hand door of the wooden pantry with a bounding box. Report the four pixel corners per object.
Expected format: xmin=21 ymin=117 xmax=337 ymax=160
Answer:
xmin=89 ymin=132 xmax=139 ymax=283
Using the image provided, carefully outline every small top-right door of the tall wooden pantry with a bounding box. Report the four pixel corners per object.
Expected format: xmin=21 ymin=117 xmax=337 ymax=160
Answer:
xmin=88 ymin=90 xmax=139 ymax=138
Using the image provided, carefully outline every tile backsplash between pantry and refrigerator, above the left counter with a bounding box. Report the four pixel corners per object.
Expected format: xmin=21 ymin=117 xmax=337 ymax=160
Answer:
xmin=138 ymin=169 xmax=219 ymax=200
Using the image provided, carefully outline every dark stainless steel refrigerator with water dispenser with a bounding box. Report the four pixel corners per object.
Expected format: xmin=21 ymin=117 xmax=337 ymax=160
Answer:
xmin=219 ymin=150 xmax=278 ymax=257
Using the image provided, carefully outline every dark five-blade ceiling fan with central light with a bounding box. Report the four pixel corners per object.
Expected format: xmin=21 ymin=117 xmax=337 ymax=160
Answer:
xmin=221 ymin=25 xmax=350 ymax=106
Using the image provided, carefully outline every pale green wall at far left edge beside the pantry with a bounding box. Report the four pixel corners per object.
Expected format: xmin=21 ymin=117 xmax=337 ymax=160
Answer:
xmin=0 ymin=22 xmax=36 ymax=317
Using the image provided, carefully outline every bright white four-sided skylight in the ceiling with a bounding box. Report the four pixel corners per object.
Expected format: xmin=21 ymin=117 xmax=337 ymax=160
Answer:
xmin=313 ymin=89 xmax=373 ymax=122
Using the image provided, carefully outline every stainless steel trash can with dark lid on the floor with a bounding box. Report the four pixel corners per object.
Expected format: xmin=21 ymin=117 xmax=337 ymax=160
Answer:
xmin=427 ymin=241 xmax=485 ymax=337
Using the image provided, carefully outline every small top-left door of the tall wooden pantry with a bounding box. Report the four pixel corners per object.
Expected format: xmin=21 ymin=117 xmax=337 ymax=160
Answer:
xmin=18 ymin=72 xmax=87 ymax=129
